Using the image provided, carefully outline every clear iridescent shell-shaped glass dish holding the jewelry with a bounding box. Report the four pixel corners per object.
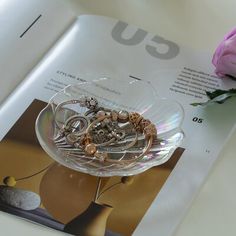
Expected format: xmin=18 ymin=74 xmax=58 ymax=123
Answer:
xmin=36 ymin=78 xmax=184 ymax=177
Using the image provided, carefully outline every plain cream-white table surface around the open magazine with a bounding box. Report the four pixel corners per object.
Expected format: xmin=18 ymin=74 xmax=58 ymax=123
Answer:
xmin=0 ymin=0 xmax=236 ymax=236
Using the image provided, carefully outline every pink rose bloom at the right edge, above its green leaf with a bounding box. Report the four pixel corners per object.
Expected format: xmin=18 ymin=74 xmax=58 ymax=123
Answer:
xmin=212 ymin=28 xmax=236 ymax=78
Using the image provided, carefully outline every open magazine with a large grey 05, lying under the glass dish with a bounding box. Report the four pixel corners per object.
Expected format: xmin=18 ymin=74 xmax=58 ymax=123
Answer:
xmin=0 ymin=0 xmax=236 ymax=236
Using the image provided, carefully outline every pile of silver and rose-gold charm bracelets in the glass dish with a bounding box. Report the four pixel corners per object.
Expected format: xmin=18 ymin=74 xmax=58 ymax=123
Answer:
xmin=54 ymin=96 xmax=157 ymax=164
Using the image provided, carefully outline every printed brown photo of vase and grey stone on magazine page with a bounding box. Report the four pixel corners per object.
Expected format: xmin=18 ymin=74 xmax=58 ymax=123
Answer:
xmin=0 ymin=100 xmax=184 ymax=236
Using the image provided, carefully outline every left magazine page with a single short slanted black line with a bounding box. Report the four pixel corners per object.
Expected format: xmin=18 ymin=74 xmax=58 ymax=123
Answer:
xmin=0 ymin=0 xmax=75 ymax=103
